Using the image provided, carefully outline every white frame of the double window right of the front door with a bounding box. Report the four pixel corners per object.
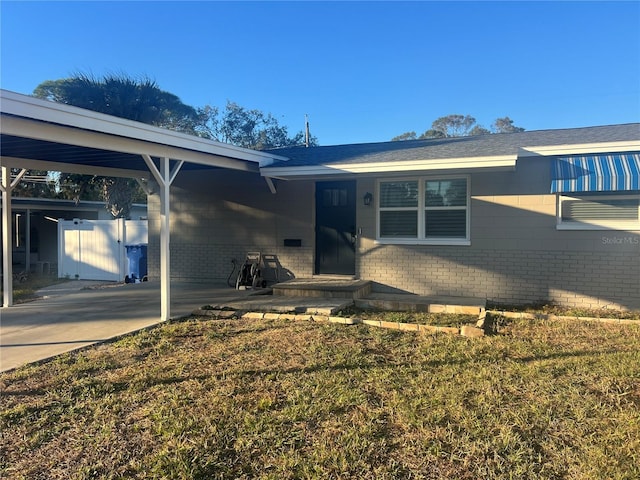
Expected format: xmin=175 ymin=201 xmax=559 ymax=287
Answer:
xmin=375 ymin=175 xmax=471 ymax=246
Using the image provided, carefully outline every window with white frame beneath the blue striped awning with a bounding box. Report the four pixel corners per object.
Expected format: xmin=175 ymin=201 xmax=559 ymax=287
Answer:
xmin=557 ymin=192 xmax=640 ymax=230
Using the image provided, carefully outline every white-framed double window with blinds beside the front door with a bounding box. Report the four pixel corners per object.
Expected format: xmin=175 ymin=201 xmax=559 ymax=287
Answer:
xmin=378 ymin=177 xmax=469 ymax=244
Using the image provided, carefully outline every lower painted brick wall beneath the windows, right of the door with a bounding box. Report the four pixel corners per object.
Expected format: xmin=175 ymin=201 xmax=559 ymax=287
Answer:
xmin=358 ymin=242 xmax=640 ymax=308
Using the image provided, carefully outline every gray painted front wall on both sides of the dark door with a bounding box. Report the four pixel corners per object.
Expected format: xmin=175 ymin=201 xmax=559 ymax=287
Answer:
xmin=148 ymin=158 xmax=640 ymax=309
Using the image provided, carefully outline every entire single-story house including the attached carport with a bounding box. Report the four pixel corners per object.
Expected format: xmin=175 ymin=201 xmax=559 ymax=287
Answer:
xmin=0 ymin=90 xmax=640 ymax=320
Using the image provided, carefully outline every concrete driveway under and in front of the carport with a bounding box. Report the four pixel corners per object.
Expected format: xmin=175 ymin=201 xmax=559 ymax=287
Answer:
xmin=0 ymin=280 xmax=251 ymax=372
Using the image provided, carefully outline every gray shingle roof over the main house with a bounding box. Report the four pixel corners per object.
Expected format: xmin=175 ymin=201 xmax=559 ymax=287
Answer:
xmin=267 ymin=123 xmax=640 ymax=168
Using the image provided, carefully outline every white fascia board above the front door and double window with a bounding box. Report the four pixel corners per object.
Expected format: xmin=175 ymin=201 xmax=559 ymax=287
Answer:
xmin=260 ymin=155 xmax=517 ymax=178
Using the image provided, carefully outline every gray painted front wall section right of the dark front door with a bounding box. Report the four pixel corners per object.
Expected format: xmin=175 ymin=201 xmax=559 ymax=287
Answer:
xmin=357 ymin=158 xmax=640 ymax=309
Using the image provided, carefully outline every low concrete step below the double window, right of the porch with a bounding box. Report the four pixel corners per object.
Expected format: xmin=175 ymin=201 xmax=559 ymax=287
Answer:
xmin=354 ymin=293 xmax=487 ymax=315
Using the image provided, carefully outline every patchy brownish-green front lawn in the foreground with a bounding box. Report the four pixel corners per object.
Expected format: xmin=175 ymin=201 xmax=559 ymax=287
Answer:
xmin=0 ymin=318 xmax=640 ymax=480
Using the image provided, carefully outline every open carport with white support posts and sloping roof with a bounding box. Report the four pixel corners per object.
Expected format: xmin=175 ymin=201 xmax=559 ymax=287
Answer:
xmin=0 ymin=90 xmax=285 ymax=320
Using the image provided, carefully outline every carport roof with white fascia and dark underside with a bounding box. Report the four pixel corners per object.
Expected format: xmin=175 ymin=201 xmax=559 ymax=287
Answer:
xmin=0 ymin=90 xmax=285 ymax=177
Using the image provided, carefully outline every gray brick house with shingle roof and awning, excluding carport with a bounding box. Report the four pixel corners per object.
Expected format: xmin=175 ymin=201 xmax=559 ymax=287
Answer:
xmin=149 ymin=124 xmax=640 ymax=309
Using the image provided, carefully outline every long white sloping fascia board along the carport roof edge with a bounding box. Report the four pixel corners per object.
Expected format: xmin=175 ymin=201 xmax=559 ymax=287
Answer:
xmin=0 ymin=90 xmax=288 ymax=166
